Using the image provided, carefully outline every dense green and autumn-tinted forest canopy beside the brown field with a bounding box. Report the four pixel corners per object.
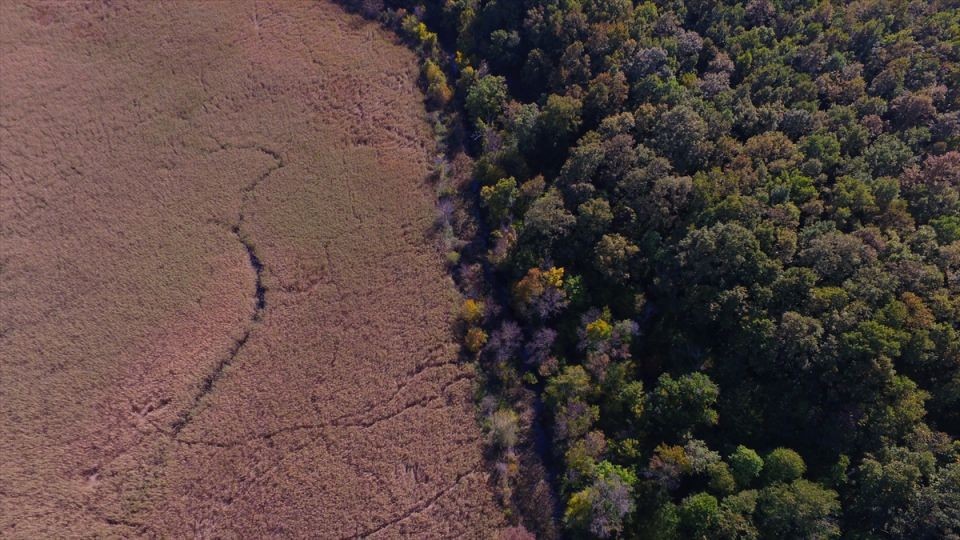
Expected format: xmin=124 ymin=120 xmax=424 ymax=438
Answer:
xmin=378 ymin=0 xmax=960 ymax=538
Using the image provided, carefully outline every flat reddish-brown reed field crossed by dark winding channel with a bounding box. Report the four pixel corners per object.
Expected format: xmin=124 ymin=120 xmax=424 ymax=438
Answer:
xmin=0 ymin=0 xmax=502 ymax=538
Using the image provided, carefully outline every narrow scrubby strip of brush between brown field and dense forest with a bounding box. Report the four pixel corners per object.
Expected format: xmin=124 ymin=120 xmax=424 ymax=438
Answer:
xmin=335 ymin=0 xmax=562 ymax=540
